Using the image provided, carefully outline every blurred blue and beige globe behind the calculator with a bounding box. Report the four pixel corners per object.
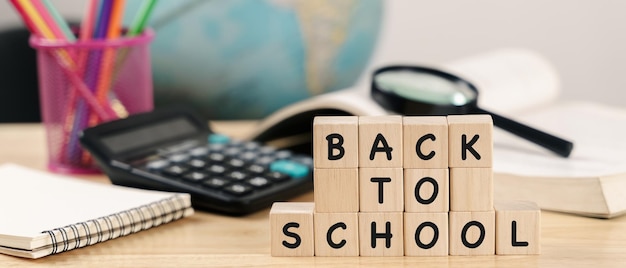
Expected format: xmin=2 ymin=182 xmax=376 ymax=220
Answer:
xmin=125 ymin=0 xmax=382 ymax=119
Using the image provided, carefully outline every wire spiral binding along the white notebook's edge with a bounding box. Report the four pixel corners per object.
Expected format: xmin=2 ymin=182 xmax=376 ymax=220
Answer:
xmin=42 ymin=195 xmax=191 ymax=254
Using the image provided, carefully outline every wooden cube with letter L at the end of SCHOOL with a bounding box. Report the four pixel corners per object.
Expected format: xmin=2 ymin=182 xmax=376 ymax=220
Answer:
xmin=495 ymin=201 xmax=541 ymax=255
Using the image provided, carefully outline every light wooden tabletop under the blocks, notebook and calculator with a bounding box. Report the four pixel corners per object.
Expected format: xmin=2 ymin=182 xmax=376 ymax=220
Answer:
xmin=0 ymin=122 xmax=626 ymax=267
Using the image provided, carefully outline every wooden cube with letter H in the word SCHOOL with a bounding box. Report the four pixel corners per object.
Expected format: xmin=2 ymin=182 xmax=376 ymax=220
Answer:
xmin=359 ymin=212 xmax=404 ymax=256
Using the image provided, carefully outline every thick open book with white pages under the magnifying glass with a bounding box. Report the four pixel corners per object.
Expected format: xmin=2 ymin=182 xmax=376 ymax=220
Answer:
xmin=250 ymin=49 xmax=626 ymax=218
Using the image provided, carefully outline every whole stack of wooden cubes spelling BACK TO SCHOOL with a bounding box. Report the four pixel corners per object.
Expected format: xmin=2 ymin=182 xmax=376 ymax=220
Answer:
xmin=270 ymin=115 xmax=540 ymax=256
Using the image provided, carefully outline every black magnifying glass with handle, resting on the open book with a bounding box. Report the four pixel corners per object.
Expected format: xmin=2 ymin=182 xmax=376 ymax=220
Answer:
xmin=371 ymin=66 xmax=574 ymax=157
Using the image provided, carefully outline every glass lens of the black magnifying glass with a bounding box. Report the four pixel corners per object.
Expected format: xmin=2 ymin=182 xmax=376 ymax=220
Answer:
xmin=374 ymin=70 xmax=477 ymax=106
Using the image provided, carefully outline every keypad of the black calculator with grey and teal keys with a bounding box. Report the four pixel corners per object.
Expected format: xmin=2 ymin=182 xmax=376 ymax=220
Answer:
xmin=135 ymin=134 xmax=313 ymax=197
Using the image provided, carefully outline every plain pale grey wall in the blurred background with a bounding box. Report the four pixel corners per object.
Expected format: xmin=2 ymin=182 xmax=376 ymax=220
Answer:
xmin=0 ymin=0 xmax=626 ymax=107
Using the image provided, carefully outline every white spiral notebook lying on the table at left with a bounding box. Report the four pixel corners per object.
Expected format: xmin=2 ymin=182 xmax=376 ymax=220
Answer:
xmin=0 ymin=164 xmax=194 ymax=258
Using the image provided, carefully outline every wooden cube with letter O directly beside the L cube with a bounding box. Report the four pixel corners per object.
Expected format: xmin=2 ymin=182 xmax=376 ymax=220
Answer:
xmin=448 ymin=211 xmax=496 ymax=256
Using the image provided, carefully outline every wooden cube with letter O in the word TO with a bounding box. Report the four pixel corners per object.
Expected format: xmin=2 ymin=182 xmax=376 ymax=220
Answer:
xmin=404 ymin=168 xmax=450 ymax=212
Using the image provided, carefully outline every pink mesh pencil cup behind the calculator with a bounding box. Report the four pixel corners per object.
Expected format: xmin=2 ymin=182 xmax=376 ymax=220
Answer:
xmin=30 ymin=29 xmax=154 ymax=174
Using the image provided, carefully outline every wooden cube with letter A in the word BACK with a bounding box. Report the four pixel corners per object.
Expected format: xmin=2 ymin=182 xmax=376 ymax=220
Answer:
xmin=359 ymin=115 xmax=402 ymax=168
